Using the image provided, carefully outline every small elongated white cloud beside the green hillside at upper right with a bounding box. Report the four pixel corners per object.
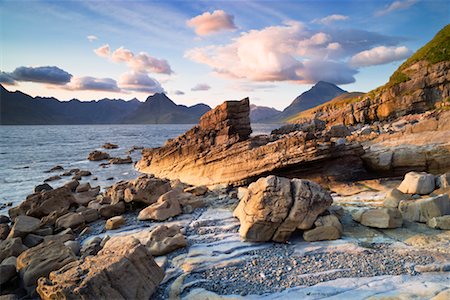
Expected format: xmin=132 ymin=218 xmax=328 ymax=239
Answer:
xmin=350 ymin=46 xmax=412 ymax=67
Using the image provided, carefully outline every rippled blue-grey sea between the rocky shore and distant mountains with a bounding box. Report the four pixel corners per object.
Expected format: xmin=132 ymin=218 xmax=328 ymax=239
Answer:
xmin=0 ymin=124 xmax=276 ymax=214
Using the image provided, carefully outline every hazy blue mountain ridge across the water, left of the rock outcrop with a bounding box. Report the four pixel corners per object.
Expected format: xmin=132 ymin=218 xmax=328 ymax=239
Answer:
xmin=0 ymin=85 xmax=211 ymax=125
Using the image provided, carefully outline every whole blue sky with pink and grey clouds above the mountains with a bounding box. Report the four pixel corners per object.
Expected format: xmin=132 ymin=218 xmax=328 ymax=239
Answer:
xmin=0 ymin=0 xmax=450 ymax=109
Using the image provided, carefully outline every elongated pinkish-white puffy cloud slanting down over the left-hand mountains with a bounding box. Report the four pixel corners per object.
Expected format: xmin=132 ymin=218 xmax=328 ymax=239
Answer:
xmin=94 ymin=45 xmax=173 ymax=74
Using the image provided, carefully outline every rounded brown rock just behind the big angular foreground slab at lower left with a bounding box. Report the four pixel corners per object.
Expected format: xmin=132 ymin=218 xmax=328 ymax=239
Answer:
xmin=146 ymin=225 xmax=187 ymax=256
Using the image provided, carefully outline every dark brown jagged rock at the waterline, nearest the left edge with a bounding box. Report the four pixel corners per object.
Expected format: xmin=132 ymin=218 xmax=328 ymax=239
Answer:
xmin=9 ymin=187 xmax=75 ymax=218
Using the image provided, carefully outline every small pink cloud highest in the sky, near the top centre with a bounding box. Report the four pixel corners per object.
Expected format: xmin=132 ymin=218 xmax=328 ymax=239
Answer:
xmin=186 ymin=10 xmax=237 ymax=36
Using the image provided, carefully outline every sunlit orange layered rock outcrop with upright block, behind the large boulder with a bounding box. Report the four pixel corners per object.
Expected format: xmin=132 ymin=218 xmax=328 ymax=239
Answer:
xmin=136 ymin=99 xmax=363 ymax=185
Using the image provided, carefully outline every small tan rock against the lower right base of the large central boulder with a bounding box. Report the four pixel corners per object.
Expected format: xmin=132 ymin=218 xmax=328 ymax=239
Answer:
xmin=303 ymin=215 xmax=342 ymax=242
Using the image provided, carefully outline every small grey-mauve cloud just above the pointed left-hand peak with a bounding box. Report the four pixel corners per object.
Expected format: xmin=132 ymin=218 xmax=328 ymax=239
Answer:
xmin=119 ymin=71 xmax=164 ymax=94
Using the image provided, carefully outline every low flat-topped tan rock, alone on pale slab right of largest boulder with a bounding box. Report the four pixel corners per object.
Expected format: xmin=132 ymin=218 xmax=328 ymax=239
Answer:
xmin=352 ymin=208 xmax=403 ymax=228
